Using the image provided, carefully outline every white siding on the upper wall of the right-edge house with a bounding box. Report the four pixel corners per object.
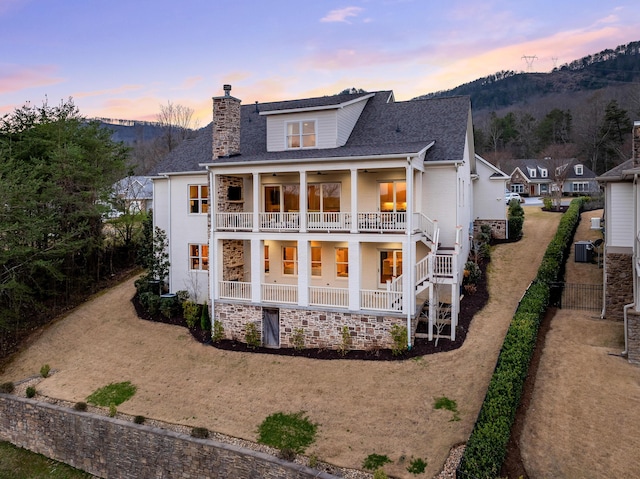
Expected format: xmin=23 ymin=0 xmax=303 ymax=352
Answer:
xmin=607 ymin=183 xmax=634 ymax=247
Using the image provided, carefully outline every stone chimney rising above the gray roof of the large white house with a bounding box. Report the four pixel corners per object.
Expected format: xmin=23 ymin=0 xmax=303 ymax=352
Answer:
xmin=213 ymin=85 xmax=240 ymax=160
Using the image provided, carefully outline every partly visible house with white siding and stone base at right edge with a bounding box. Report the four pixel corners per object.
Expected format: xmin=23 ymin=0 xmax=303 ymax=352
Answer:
xmin=598 ymin=121 xmax=640 ymax=363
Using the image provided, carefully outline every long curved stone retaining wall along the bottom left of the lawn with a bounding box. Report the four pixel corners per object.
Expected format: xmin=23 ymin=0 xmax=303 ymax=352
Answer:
xmin=0 ymin=394 xmax=337 ymax=479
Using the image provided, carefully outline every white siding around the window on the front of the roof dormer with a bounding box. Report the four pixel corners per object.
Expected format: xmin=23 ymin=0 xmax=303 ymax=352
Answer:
xmin=267 ymin=110 xmax=338 ymax=151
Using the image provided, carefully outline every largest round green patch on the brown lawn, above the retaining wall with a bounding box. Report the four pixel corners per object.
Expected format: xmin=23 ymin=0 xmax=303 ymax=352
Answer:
xmin=258 ymin=411 xmax=318 ymax=456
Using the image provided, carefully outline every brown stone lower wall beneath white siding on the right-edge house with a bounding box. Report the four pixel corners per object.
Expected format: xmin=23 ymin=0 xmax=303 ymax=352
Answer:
xmin=604 ymin=253 xmax=633 ymax=321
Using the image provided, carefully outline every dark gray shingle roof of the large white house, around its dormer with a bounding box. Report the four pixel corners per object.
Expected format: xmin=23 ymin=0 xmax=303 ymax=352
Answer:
xmin=154 ymin=91 xmax=471 ymax=174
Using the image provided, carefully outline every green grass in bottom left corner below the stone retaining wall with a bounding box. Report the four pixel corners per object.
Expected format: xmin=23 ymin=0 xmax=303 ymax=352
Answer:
xmin=0 ymin=442 xmax=93 ymax=479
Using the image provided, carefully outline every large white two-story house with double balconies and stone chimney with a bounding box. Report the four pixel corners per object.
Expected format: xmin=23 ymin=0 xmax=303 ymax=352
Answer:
xmin=153 ymin=85 xmax=506 ymax=349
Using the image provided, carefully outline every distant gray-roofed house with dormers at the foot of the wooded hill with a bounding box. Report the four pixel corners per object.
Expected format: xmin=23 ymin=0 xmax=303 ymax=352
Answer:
xmin=500 ymin=158 xmax=599 ymax=196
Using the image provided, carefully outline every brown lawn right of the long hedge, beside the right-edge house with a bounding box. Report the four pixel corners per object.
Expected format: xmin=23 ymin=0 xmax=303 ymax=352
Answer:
xmin=520 ymin=212 xmax=640 ymax=478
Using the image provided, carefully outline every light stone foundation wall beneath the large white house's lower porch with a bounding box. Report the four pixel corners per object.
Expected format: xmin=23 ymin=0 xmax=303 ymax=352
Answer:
xmin=214 ymin=301 xmax=417 ymax=350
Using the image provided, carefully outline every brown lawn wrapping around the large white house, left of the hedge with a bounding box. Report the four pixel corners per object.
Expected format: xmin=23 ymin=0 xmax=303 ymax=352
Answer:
xmin=0 ymin=207 xmax=560 ymax=478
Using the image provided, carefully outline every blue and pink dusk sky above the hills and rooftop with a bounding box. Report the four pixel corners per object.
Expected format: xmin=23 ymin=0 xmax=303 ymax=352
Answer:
xmin=0 ymin=0 xmax=640 ymax=126
